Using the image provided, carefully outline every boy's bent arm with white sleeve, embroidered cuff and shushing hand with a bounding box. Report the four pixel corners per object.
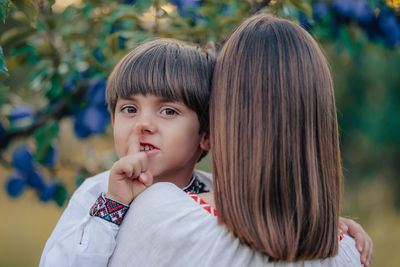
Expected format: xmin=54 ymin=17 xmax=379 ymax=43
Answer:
xmin=40 ymin=136 xmax=153 ymax=267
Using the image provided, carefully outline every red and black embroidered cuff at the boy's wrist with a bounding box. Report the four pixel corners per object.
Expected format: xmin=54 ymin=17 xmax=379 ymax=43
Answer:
xmin=89 ymin=193 xmax=129 ymax=225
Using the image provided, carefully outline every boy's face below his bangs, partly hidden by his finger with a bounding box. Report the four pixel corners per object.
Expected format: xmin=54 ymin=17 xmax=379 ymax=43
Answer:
xmin=112 ymin=94 xmax=209 ymax=187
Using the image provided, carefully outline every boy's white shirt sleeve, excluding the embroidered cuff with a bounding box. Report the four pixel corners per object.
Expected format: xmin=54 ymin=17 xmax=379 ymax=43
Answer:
xmin=39 ymin=172 xmax=119 ymax=267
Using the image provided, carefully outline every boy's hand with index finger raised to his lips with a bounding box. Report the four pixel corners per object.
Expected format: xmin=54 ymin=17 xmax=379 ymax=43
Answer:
xmin=106 ymin=135 xmax=153 ymax=205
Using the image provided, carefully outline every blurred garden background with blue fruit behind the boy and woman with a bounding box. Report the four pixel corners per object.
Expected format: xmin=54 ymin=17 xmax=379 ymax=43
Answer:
xmin=0 ymin=0 xmax=400 ymax=267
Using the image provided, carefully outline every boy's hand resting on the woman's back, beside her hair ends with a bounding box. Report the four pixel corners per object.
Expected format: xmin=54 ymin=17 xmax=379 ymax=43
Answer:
xmin=339 ymin=217 xmax=374 ymax=266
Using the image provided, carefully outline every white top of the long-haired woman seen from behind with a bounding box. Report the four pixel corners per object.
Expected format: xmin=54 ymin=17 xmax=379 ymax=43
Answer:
xmin=109 ymin=183 xmax=361 ymax=267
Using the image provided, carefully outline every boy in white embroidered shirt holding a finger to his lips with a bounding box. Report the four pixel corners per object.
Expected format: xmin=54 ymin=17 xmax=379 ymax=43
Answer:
xmin=40 ymin=40 xmax=215 ymax=266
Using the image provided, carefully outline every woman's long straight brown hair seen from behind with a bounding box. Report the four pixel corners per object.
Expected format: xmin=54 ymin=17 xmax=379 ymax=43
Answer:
xmin=210 ymin=15 xmax=342 ymax=261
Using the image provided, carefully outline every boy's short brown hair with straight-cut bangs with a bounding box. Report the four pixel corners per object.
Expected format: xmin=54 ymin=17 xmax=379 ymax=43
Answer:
xmin=106 ymin=39 xmax=215 ymax=135
